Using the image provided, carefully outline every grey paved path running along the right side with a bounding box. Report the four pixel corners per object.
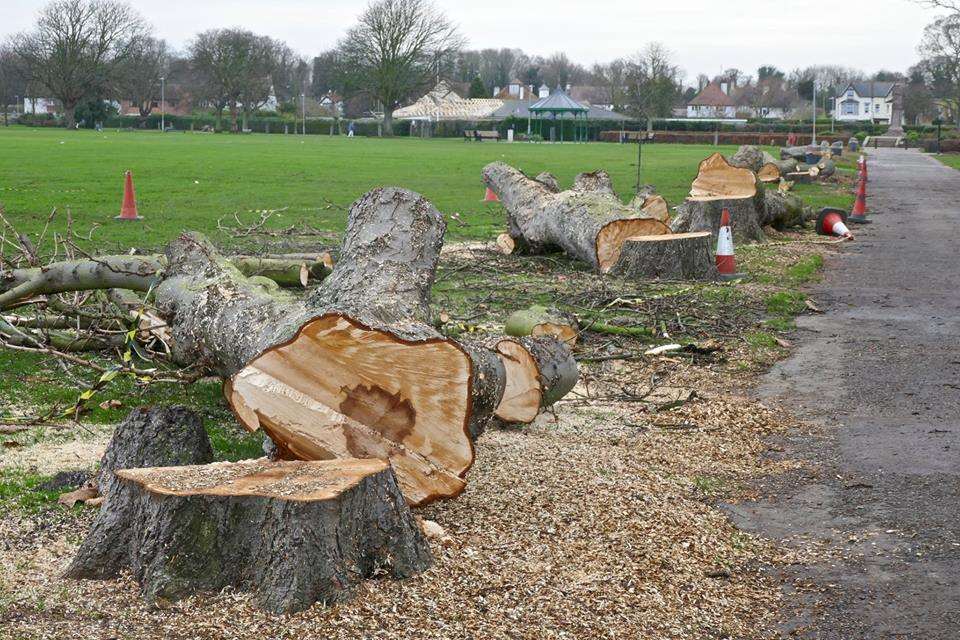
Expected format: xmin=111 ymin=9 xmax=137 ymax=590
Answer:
xmin=730 ymin=149 xmax=960 ymax=640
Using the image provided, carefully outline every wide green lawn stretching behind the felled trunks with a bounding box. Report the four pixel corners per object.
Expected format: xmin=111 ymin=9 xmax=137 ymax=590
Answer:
xmin=0 ymin=127 xmax=846 ymax=250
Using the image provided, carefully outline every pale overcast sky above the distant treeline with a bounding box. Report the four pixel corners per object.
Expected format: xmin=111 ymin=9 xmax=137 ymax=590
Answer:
xmin=0 ymin=0 xmax=936 ymax=83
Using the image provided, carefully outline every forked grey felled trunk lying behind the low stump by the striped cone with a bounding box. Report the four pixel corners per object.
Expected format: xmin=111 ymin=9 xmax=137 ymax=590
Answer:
xmin=483 ymin=162 xmax=669 ymax=273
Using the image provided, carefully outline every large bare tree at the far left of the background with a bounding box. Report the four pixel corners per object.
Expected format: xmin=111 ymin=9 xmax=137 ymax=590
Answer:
xmin=13 ymin=0 xmax=147 ymax=127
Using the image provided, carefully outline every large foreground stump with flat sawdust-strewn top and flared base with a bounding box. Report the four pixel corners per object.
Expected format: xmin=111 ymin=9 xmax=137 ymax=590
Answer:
xmin=66 ymin=459 xmax=431 ymax=613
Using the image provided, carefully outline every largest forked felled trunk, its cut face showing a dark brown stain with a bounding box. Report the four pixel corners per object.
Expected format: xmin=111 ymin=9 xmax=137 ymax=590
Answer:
xmin=1 ymin=188 xmax=576 ymax=504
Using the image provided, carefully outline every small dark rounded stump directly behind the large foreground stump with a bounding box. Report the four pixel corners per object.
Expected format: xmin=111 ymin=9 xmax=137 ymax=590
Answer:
xmin=97 ymin=406 xmax=213 ymax=495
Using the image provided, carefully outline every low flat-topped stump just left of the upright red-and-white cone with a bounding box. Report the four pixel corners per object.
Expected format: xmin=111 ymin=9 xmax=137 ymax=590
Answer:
xmin=612 ymin=231 xmax=717 ymax=280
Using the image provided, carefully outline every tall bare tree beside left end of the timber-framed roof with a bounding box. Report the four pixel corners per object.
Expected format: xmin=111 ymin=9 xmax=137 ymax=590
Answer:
xmin=337 ymin=0 xmax=463 ymax=136
